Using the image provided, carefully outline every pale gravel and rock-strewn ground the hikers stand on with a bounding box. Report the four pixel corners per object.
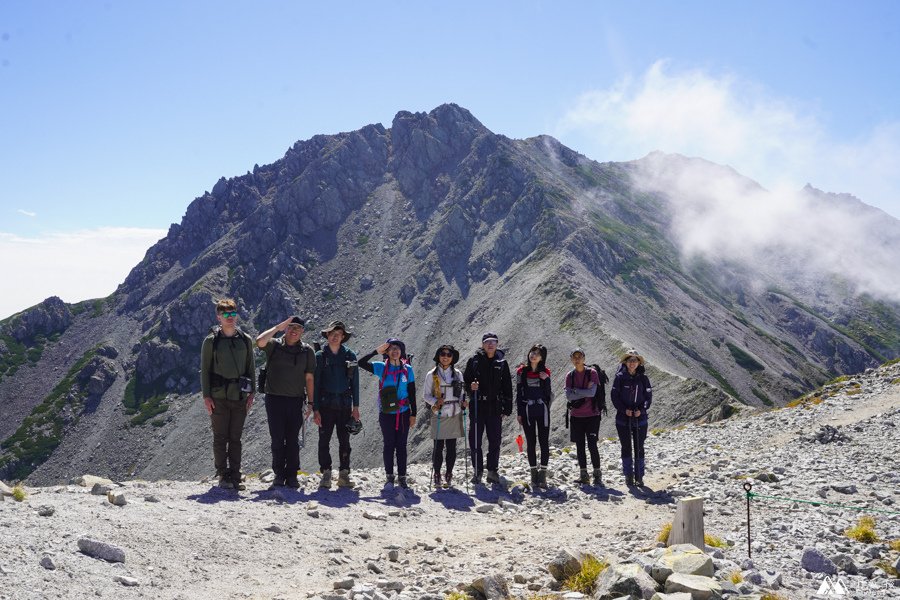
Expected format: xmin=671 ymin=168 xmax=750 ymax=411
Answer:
xmin=0 ymin=362 xmax=900 ymax=600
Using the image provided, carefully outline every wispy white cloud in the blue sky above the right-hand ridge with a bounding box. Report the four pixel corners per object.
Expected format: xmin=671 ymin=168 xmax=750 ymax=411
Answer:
xmin=557 ymin=61 xmax=900 ymax=217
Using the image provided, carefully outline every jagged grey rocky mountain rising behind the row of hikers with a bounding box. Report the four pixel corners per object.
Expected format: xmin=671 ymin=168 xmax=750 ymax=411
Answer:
xmin=0 ymin=104 xmax=900 ymax=482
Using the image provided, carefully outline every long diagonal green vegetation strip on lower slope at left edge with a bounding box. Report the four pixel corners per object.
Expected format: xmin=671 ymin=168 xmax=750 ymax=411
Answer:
xmin=0 ymin=346 xmax=99 ymax=479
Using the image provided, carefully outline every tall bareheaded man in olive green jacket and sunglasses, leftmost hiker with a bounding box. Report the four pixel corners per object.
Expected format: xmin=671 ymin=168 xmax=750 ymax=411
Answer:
xmin=200 ymin=298 xmax=256 ymax=490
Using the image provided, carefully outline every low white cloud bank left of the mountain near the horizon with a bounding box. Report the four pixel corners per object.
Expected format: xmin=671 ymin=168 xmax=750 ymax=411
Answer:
xmin=0 ymin=227 xmax=166 ymax=318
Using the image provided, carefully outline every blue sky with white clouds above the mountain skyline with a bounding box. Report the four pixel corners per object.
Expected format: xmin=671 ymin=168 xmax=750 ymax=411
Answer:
xmin=0 ymin=0 xmax=900 ymax=318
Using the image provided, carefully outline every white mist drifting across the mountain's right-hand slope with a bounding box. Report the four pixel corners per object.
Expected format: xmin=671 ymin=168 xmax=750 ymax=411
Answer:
xmin=635 ymin=154 xmax=900 ymax=302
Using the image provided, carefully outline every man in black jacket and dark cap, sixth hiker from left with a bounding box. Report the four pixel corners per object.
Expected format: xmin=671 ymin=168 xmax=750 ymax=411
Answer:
xmin=463 ymin=332 xmax=512 ymax=484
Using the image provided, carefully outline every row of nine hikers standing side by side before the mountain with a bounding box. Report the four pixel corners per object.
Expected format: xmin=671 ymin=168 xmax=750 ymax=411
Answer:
xmin=200 ymin=298 xmax=653 ymax=490
